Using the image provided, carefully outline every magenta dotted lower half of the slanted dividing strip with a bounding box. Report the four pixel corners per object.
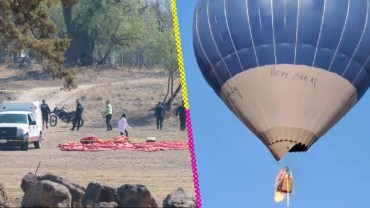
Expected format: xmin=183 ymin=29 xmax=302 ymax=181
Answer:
xmin=185 ymin=109 xmax=202 ymax=208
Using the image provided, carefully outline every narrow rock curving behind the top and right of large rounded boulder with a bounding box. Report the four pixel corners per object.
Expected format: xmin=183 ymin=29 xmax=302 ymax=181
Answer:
xmin=39 ymin=174 xmax=85 ymax=207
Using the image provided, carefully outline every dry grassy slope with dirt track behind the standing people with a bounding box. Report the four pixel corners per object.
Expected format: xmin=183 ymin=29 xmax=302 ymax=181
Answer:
xmin=0 ymin=68 xmax=181 ymax=125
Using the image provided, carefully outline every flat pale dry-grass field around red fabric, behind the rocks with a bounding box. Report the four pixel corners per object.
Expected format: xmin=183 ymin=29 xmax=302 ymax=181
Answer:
xmin=0 ymin=123 xmax=194 ymax=206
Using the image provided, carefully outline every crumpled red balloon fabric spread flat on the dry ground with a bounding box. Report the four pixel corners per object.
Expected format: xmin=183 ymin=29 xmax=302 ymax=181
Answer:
xmin=58 ymin=136 xmax=188 ymax=152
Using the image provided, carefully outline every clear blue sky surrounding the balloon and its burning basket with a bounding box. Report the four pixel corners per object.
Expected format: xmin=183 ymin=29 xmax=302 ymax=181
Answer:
xmin=177 ymin=0 xmax=370 ymax=208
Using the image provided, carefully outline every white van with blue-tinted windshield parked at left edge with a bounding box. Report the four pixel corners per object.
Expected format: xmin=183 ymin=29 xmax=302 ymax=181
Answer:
xmin=0 ymin=101 xmax=42 ymax=151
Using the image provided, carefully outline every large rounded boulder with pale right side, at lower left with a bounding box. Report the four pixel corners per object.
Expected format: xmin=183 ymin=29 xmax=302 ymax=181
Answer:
xmin=22 ymin=180 xmax=72 ymax=207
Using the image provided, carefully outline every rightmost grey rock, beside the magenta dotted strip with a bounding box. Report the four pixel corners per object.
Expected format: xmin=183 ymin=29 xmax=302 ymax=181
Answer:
xmin=163 ymin=188 xmax=196 ymax=208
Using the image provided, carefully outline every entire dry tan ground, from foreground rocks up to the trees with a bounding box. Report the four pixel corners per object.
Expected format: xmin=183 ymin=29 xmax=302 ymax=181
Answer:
xmin=0 ymin=66 xmax=195 ymax=206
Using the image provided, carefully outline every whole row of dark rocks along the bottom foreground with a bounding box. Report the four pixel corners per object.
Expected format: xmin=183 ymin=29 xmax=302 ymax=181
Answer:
xmin=0 ymin=173 xmax=196 ymax=207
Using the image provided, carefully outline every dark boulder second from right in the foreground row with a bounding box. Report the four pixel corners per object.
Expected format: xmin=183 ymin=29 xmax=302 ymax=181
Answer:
xmin=117 ymin=184 xmax=158 ymax=207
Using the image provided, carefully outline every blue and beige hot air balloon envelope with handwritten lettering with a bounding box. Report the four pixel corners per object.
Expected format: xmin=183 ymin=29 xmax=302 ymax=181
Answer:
xmin=193 ymin=0 xmax=370 ymax=160
